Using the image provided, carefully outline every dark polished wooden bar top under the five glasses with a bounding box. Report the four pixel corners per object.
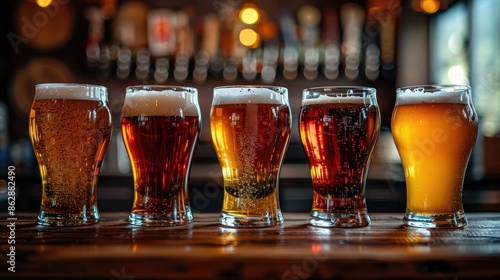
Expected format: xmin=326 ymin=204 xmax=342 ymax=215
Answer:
xmin=0 ymin=213 xmax=500 ymax=280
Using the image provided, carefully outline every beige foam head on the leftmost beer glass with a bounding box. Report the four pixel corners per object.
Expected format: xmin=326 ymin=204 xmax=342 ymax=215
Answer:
xmin=35 ymin=84 xmax=108 ymax=101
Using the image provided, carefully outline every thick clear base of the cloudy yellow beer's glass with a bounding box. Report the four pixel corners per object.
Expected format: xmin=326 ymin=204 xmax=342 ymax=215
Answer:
xmin=403 ymin=212 xmax=467 ymax=228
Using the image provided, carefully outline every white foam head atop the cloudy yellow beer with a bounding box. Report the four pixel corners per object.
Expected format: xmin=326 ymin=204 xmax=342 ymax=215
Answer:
xmin=396 ymin=86 xmax=470 ymax=105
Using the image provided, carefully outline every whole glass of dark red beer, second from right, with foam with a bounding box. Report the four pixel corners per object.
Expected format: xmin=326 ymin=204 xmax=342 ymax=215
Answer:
xmin=299 ymin=87 xmax=380 ymax=227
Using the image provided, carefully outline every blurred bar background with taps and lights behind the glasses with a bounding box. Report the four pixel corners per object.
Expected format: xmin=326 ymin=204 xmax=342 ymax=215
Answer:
xmin=0 ymin=0 xmax=500 ymax=213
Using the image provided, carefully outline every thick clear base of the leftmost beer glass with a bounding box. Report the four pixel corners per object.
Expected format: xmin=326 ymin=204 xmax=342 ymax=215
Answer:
xmin=38 ymin=209 xmax=99 ymax=226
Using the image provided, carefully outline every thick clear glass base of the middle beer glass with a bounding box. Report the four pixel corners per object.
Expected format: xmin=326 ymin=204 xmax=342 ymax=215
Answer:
xmin=219 ymin=210 xmax=284 ymax=227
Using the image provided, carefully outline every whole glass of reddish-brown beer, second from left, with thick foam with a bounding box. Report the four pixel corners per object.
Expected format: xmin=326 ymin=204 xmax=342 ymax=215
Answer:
xmin=121 ymin=86 xmax=201 ymax=226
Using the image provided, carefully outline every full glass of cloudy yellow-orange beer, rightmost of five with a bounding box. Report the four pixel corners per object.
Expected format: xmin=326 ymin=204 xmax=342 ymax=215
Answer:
xmin=391 ymin=85 xmax=478 ymax=228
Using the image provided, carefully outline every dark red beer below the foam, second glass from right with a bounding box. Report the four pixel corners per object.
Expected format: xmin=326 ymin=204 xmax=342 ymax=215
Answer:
xmin=299 ymin=92 xmax=380 ymax=228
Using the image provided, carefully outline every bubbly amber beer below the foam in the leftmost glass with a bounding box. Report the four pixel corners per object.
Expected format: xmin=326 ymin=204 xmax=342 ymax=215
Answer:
xmin=30 ymin=99 xmax=111 ymax=212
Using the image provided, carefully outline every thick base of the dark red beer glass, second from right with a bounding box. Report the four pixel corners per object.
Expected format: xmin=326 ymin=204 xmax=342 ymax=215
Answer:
xmin=308 ymin=211 xmax=371 ymax=228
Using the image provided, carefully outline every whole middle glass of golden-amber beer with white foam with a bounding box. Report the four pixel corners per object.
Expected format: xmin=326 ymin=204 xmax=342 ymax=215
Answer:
xmin=210 ymin=86 xmax=291 ymax=227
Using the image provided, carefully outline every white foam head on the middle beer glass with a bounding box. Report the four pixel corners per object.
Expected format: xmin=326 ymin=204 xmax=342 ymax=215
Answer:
xmin=212 ymin=86 xmax=288 ymax=105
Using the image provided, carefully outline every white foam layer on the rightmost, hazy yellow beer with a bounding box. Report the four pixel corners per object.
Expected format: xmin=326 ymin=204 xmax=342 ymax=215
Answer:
xmin=397 ymin=87 xmax=469 ymax=105
